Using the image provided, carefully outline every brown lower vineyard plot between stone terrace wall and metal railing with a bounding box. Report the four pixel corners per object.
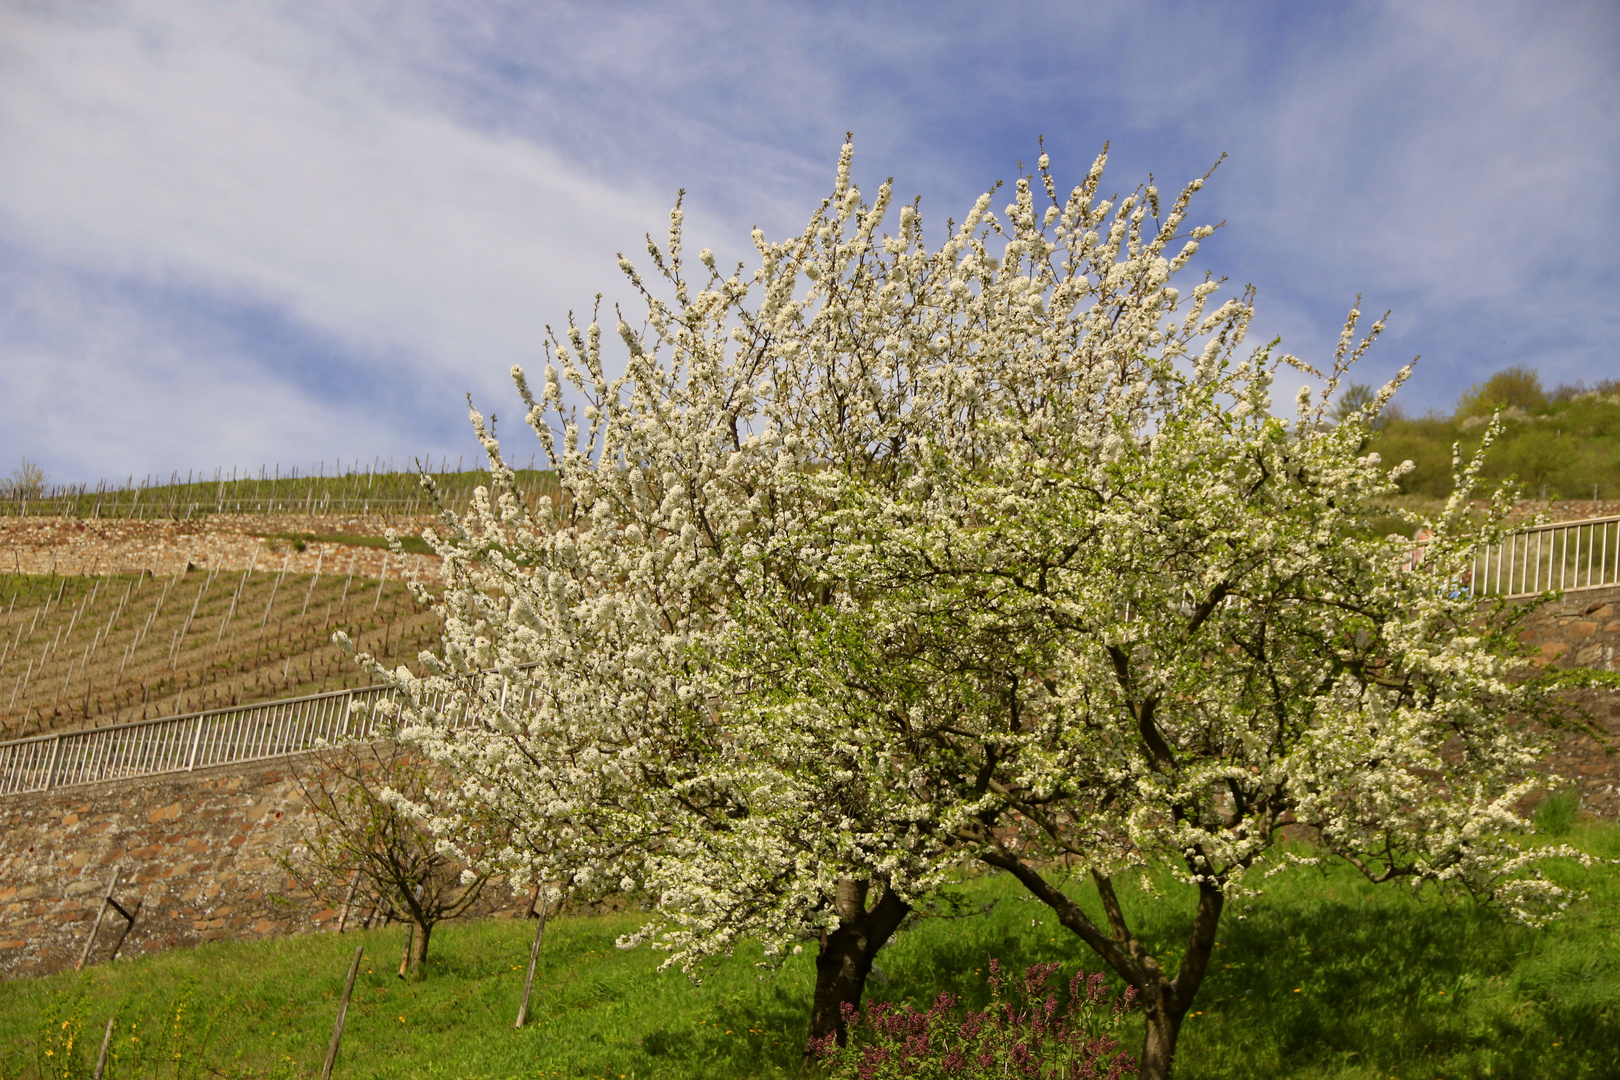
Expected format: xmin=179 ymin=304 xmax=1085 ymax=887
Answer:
xmin=0 ymin=551 xmax=437 ymax=738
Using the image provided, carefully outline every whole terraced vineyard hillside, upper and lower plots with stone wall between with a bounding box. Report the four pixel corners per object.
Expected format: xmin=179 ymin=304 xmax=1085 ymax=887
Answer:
xmin=0 ymin=458 xmax=576 ymax=738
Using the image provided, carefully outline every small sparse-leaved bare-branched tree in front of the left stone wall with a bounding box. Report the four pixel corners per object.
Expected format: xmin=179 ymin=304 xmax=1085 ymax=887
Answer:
xmin=279 ymin=740 xmax=489 ymax=973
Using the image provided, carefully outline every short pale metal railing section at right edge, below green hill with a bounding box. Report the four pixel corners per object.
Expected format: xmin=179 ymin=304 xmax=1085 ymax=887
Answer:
xmin=1468 ymin=517 xmax=1620 ymax=597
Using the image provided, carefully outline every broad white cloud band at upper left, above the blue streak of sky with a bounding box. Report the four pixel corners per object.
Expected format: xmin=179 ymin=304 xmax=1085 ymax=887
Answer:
xmin=0 ymin=5 xmax=690 ymax=396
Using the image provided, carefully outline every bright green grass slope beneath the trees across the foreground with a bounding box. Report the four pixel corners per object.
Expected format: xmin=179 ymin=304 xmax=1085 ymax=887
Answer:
xmin=0 ymin=824 xmax=1620 ymax=1080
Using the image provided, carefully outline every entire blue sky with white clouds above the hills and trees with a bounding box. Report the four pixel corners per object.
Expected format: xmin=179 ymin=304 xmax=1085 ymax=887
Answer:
xmin=0 ymin=0 xmax=1620 ymax=479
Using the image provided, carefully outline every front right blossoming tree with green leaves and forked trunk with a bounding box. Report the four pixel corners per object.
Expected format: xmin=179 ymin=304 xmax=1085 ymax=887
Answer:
xmin=750 ymin=333 xmax=1594 ymax=1077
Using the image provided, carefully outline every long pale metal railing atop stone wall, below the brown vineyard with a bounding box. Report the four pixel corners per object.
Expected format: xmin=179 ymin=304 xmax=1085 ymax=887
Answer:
xmin=0 ymin=687 xmax=401 ymax=795
